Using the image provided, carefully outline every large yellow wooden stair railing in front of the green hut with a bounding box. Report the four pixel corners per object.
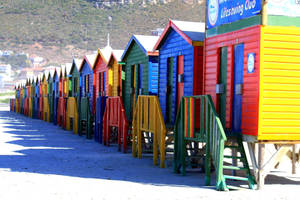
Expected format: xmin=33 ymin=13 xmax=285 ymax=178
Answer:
xmin=132 ymin=95 xmax=167 ymax=168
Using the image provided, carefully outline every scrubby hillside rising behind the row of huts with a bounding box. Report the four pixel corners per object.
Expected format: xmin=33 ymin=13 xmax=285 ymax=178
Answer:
xmin=0 ymin=0 xmax=204 ymax=61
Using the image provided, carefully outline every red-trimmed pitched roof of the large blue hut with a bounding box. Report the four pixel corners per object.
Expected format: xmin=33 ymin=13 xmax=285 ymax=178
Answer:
xmin=154 ymin=20 xmax=205 ymax=50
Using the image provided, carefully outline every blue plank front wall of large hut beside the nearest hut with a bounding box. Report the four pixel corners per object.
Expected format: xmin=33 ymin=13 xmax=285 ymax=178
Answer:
xmin=158 ymin=30 xmax=194 ymax=123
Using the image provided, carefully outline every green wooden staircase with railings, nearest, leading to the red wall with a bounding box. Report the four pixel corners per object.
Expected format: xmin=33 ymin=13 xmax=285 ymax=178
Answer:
xmin=174 ymin=95 xmax=255 ymax=191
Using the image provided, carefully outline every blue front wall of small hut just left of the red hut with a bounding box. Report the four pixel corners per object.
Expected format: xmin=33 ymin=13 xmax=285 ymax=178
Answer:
xmin=80 ymin=60 xmax=93 ymax=112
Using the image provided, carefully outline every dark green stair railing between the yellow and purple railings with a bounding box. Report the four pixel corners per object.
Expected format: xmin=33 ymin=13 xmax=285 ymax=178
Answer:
xmin=79 ymin=97 xmax=92 ymax=139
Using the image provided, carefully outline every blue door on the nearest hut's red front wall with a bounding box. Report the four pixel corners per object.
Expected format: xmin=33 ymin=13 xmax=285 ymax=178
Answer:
xmin=232 ymin=44 xmax=244 ymax=133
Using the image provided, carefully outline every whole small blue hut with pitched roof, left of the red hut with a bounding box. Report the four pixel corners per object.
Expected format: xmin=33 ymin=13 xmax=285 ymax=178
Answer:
xmin=79 ymin=54 xmax=97 ymax=112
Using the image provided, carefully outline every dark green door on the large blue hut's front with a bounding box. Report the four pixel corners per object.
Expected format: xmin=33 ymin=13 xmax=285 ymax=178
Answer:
xmin=166 ymin=57 xmax=174 ymax=124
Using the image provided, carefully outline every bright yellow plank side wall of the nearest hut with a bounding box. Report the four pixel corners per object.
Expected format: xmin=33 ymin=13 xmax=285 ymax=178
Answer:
xmin=258 ymin=26 xmax=300 ymax=140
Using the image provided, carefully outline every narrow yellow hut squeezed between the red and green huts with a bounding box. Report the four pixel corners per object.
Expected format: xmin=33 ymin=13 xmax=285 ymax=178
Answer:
xmin=107 ymin=50 xmax=124 ymax=96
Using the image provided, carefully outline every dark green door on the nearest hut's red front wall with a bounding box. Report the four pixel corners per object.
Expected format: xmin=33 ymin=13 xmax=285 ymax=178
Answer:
xmin=216 ymin=47 xmax=227 ymax=127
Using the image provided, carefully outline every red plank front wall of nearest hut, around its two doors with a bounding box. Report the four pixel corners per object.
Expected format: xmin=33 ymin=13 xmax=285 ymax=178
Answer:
xmin=204 ymin=26 xmax=260 ymax=135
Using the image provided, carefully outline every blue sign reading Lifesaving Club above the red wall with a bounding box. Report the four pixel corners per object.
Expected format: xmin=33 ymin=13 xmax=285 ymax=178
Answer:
xmin=206 ymin=0 xmax=261 ymax=29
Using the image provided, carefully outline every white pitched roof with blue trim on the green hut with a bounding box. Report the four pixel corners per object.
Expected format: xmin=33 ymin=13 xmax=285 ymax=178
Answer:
xmin=121 ymin=35 xmax=159 ymax=60
